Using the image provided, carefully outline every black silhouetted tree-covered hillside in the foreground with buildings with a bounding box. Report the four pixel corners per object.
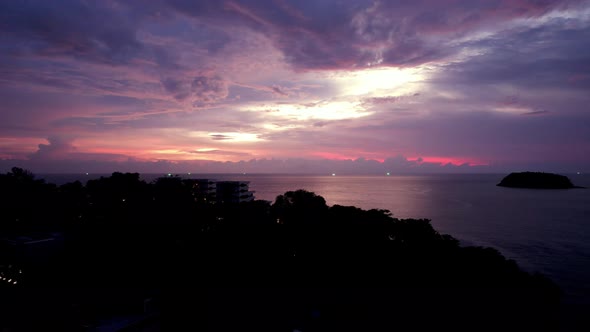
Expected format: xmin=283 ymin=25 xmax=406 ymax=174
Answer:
xmin=0 ymin=168 xmax=560 ymax=331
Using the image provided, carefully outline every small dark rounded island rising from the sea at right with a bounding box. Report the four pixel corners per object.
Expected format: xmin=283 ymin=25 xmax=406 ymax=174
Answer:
xmin=497 ymin=172 xmax=582 ymax=189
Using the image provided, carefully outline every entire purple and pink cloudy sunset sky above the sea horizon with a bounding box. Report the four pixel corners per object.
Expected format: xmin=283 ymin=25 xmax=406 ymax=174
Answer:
xmin=0 ymin=0 xmax=590 ymax=174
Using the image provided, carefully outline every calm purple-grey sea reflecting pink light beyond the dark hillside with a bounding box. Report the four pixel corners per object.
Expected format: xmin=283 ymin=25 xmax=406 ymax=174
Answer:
xmin=38 ymin=174 xmax=590 ymax=331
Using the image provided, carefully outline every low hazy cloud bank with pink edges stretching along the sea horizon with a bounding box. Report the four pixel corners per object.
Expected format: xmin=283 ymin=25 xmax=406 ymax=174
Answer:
xmin=0 ymin=156 xmax=580 ymax=175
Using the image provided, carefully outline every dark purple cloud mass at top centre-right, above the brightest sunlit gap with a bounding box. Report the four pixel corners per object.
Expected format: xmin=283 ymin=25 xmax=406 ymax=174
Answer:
xmin=156 ymin=0 xmax=579 ymax=69
